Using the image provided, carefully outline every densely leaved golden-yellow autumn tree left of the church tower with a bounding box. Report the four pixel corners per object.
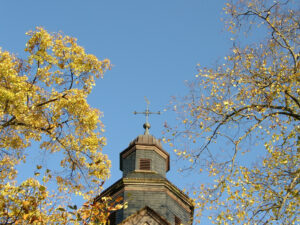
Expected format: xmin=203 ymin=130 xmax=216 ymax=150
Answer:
xmin=0 ymin=27 xmax=120 ymax=224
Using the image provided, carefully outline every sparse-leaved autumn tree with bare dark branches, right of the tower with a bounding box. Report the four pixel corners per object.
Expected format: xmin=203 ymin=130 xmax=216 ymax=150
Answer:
xmin=166 ymin=0 xmax=300 ymax=225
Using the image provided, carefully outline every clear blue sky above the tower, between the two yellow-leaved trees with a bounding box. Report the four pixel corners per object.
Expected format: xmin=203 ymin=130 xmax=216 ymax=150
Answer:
xmin=0 ymin=0 xmax=231 ymax=224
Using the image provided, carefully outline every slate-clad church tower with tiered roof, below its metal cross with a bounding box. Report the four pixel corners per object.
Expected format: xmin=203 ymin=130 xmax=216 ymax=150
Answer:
xmin=96 ymin=122 xmax=194 ymax=225
